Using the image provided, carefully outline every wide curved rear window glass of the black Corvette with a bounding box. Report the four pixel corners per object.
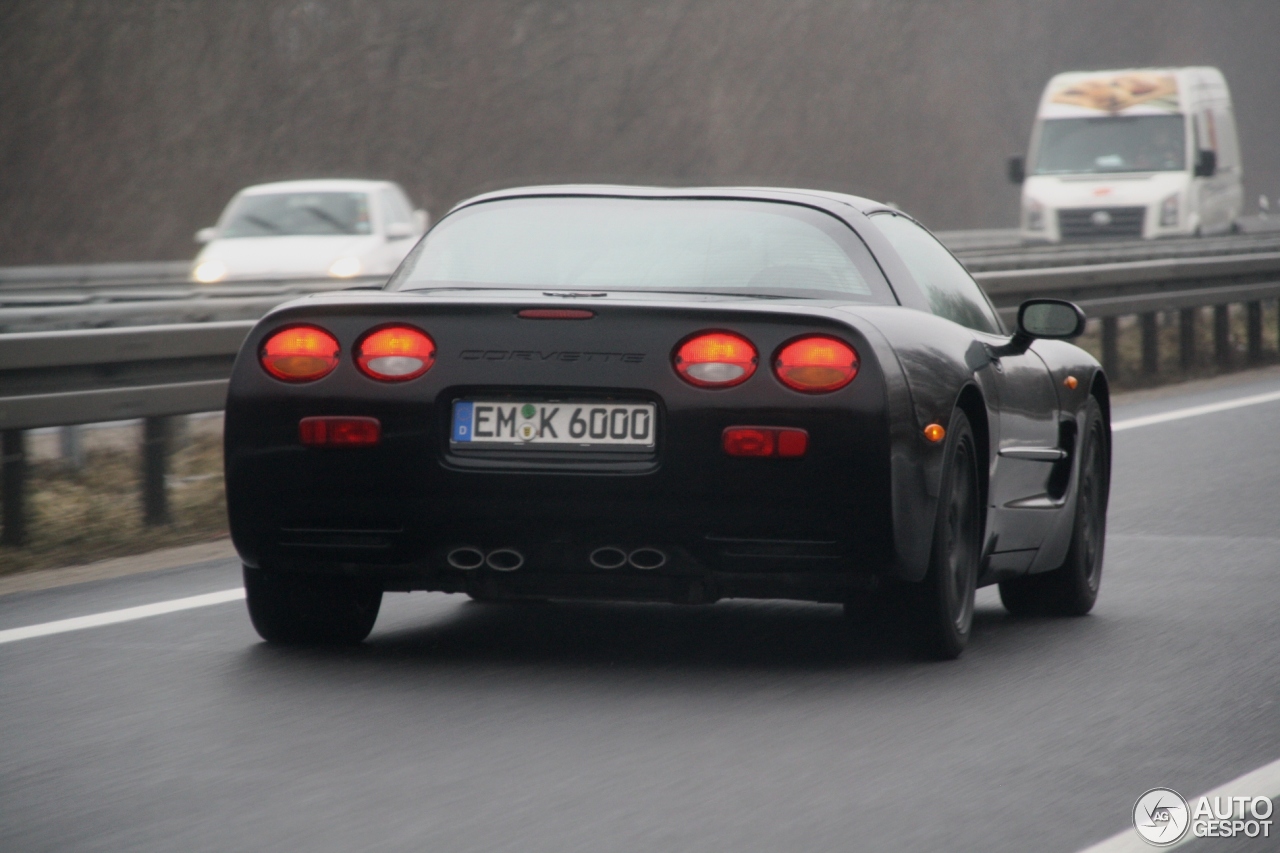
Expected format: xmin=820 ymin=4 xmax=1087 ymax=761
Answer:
xmin=388 ymin=197 xmax=892 ymax=302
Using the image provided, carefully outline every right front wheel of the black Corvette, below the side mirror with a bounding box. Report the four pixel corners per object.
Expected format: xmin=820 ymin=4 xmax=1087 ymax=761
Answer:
xmin=1000 ymin=397 xmax=1110 ymax=616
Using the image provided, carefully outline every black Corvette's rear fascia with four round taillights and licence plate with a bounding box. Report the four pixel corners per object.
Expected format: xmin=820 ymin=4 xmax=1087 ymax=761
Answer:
xmin=225 ymin=292 xmax=892 ymax=602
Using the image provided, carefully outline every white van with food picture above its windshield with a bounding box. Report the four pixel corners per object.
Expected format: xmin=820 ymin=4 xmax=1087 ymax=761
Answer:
xmin=1009 ymin=67 xmax=1244 ymax=242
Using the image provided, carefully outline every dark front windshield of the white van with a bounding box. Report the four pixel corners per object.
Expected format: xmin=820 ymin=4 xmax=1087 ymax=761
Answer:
xmin=1033 ymin=115 xmax=1187 ymax=174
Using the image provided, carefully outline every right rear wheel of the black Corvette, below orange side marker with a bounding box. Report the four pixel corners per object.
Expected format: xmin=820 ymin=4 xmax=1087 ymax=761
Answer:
xmin=904 ymin=410 xmax=983 ymax=661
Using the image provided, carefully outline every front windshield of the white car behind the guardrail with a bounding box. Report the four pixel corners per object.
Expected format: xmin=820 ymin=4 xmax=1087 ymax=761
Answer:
xmin=218 ymin=192 xmax=372 ymax=237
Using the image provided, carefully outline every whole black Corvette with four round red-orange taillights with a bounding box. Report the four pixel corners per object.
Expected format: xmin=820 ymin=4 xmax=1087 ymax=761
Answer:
xmin=225 ymin=187 xmax=1110 ymax=657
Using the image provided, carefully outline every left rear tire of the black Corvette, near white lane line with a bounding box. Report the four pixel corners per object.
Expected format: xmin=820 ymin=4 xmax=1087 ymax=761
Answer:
xmin=244 ymin=566 xmax=383 ymax=646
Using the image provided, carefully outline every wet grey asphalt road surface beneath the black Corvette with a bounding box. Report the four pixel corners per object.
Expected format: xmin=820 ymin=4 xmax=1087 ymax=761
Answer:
xmin=0 ymin=378 xmax=1280 ymax=853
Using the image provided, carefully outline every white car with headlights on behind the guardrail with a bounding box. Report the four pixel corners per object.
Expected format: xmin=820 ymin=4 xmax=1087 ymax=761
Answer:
xmin=191 ymin=179 xmax=428 ymax=284
